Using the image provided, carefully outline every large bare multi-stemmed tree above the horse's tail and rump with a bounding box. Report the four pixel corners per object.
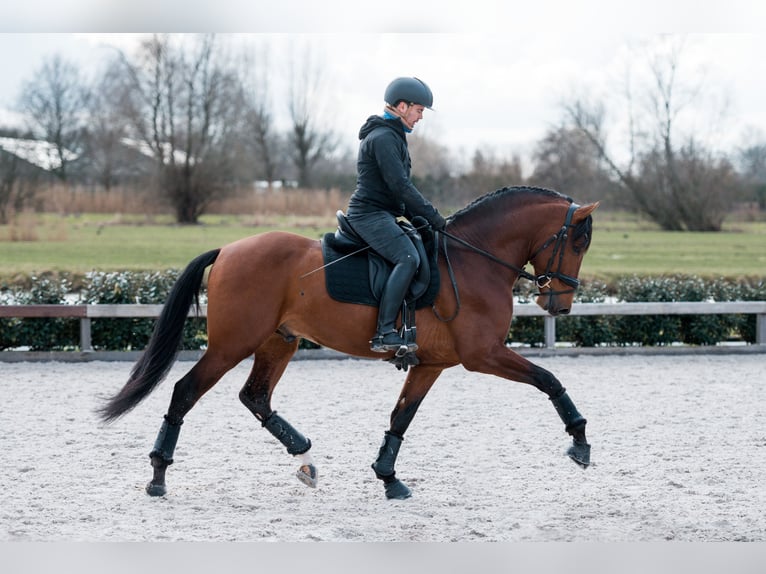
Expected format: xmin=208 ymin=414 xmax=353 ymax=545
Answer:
xmin=114 ymin=35 xmax=240 ymax=223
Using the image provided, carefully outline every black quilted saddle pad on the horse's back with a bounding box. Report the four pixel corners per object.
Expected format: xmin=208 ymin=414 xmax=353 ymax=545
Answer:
xmin=322 ymin=233 xmax=440 ymax=309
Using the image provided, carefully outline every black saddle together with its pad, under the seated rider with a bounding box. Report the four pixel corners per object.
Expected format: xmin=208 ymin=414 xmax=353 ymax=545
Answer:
xmin=322 ymin=211 xmax=439 ymax=309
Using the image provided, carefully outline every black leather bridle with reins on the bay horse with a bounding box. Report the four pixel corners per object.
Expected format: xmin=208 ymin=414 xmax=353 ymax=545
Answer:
xmin=433 ymin=202 xmax=580 ymax=322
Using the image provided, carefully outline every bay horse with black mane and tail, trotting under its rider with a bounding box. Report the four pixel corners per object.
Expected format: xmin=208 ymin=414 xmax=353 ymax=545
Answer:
xmin=98 ymin=186 xmax=599 ymax=499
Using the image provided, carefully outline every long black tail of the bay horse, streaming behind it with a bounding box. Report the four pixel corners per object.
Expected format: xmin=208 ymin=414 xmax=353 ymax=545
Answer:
xmin=98 ymin=249 xmax=221 ymax=422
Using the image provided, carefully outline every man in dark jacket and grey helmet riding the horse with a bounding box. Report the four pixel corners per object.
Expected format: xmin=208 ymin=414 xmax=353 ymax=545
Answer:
xmin=347 ymin=78 xmax=446 ymax=353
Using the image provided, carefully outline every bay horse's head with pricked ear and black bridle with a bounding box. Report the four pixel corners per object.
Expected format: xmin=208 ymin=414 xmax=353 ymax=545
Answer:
xmin=529 ymin=202 xmax=599 ymax=316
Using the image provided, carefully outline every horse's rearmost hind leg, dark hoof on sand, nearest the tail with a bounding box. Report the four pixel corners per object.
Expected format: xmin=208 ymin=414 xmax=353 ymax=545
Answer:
xmin=146 ymin=353 xmax=234 ymax=496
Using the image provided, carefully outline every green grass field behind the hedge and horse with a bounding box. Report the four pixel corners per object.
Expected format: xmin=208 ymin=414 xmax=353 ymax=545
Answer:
xmin=0 ymin=212 xmax=766 ymax=282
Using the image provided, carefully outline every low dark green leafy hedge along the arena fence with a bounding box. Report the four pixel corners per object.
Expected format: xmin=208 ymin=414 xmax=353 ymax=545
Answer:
xmin=0 ymin=270 xmax=766 ymax=351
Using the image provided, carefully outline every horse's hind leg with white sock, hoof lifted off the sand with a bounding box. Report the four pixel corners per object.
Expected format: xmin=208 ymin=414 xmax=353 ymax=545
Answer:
xmin=239 ymin=334 xmax=318 ymax=488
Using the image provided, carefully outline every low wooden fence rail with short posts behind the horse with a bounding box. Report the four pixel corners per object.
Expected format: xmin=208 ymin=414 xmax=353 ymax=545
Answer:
xmin=0 ymin=301 xmax=766 ymax=352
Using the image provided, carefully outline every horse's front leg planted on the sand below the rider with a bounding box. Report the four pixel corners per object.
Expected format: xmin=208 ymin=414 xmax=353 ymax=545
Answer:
xmin=372 ymin=365 xmax=442 ymax=500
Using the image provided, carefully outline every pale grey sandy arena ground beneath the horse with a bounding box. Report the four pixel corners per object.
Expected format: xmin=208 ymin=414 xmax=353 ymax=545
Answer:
xmin=0 ymin=354 xmax=766 ymax=542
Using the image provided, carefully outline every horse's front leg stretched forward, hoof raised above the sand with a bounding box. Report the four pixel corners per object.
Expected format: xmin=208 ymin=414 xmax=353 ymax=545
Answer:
xmin=463 ymin=344 xmax=590 ymax=468
